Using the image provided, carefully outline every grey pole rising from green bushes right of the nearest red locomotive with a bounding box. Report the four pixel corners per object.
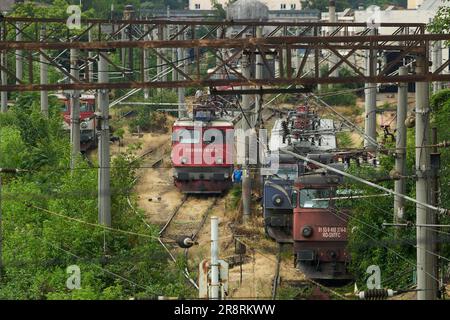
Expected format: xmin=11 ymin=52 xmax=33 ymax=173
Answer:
xmin=394 ymin=66 xmax=408 ymax=223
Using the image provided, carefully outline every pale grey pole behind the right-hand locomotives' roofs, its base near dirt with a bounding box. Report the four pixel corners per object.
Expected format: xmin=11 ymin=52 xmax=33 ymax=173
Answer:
xmin=364 ymin=29 xmax=377 ymax=150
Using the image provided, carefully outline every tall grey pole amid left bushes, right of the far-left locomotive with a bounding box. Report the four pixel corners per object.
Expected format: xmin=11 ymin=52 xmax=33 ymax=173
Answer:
xmin=98 ymin=53 xmax=111 ymax=227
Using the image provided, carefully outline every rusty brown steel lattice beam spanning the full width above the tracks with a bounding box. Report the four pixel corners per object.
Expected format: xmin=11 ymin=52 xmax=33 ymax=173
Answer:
xmin=0 ymin=18 xmax=450 ymax=92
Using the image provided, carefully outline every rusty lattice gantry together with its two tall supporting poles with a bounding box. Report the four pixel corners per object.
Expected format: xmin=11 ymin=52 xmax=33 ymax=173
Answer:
xmin=0 ymin=16 xmax=450 ymax=299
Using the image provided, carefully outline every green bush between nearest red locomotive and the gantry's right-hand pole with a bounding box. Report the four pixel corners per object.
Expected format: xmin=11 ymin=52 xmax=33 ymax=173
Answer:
xmin=341 ymin=162 xmax=415 ymax=290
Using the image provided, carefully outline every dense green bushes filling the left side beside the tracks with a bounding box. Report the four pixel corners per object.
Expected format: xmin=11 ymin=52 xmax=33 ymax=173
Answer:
xmin=0 ymin=97 xmax=193 ymax=299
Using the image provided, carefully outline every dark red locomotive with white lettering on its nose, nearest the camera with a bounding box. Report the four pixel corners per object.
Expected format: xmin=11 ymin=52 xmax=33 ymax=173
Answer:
xmin=292 ymin=172 xmax=352 ymax=282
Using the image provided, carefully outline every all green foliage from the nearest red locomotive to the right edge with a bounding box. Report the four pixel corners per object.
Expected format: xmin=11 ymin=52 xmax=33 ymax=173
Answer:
xmin=341 ymin=90 xmax=450 ymax=289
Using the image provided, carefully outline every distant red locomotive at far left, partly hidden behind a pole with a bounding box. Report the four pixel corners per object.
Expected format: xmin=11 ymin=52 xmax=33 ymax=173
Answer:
xmin=56 ymin=94 xmax=97 ymax=152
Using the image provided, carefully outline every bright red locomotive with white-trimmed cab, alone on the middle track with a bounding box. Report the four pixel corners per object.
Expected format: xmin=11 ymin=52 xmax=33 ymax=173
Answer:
xmin=171 ymin=105 xmax=234 ymax=193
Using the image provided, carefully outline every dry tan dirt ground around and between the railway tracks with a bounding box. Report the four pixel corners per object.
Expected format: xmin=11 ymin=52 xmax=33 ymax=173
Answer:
xmin=125 ymin=95 xmax=434 ymax=299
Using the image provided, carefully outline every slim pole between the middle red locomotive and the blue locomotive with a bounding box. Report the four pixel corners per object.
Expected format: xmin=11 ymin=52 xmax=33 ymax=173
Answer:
xmin=241 ymin=53 xmax=252 ymax=222
